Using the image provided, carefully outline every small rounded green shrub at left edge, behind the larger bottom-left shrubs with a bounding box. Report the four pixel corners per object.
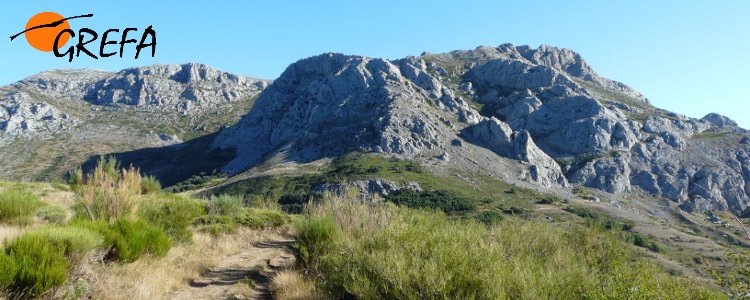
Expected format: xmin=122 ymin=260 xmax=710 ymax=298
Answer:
xmin=0 ymin=187 xmax=44 ymax=224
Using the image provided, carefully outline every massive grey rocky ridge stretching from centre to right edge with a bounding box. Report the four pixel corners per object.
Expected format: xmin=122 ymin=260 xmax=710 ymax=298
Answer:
xmin=215 ymin=44 xmax=750 ymax=212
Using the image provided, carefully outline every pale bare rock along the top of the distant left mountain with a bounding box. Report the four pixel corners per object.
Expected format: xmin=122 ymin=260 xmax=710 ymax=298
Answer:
xmin=0 ymin=64 xmax=270 ymax=144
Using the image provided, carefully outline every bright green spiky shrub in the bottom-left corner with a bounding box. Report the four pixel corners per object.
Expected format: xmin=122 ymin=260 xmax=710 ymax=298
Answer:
xmin=7 ymin=235 xmax=69 ymax=296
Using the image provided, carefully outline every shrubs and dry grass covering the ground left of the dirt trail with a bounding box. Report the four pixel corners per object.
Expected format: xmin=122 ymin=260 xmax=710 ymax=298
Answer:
xmin=0 ymin=158 xmax=288 ymax=299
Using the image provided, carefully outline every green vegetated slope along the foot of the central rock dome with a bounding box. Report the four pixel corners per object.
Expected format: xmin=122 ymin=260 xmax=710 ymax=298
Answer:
xmin=209 ymin=153 xmax=546 ymax=216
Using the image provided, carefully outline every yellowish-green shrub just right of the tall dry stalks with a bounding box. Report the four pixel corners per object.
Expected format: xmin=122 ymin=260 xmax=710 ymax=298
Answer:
xmin=138 ymin=195 xmax=206 ymax=242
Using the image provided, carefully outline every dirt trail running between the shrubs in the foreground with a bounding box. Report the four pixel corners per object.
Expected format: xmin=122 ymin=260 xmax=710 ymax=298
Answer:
xmin=170 ymin=239 xmax=294 ymax=300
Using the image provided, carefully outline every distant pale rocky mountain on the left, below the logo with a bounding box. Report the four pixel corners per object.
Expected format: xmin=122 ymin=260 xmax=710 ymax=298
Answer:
xmin=0 ymin=64 xmax=270 ymax=180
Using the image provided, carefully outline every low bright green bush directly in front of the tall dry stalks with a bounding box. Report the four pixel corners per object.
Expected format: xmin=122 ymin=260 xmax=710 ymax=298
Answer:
xmin=76 ymin=219 xmax=171 ymax=262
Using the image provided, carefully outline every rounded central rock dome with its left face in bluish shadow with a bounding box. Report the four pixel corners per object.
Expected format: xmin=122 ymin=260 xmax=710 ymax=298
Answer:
xmin=216 ymin=54 xmax=466 ymax=172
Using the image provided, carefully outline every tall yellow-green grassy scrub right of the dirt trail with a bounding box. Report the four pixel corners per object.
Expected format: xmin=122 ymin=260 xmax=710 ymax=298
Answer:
xmin=298 ymin=199 xmax=722 ymax=299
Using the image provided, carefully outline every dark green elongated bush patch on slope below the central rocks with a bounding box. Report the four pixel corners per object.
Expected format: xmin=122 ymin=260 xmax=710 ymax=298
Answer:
xmin=385 ymin=189 xmax=476 ymax=213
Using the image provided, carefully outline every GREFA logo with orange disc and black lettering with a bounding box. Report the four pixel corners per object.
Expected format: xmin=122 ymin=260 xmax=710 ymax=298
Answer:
xmin=10 ymin=12 xmax=156 ymax=62
